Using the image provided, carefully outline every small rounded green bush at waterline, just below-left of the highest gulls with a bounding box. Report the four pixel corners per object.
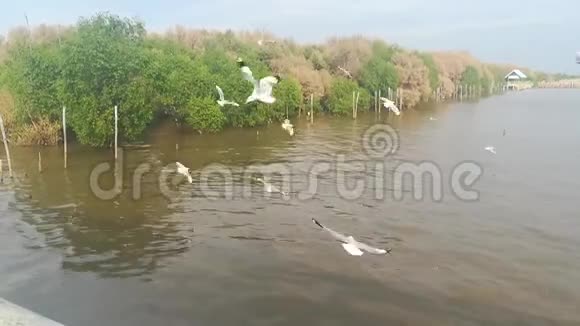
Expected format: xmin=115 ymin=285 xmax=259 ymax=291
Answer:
xmin=185 ymin=97 xmax=226 ymax=132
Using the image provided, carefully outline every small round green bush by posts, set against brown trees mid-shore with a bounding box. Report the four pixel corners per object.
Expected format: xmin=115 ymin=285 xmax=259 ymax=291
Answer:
xmin=327 ymin=78 xmax=371 ymax=115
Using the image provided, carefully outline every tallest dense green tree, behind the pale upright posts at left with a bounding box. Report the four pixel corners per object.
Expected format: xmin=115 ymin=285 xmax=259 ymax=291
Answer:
xmin=60 ymin=14 xmax=154 ymax=146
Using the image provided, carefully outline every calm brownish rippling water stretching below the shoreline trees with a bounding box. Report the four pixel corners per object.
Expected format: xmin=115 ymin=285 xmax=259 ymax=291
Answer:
xmin=0 ymin=90 xmax=580 ymax=326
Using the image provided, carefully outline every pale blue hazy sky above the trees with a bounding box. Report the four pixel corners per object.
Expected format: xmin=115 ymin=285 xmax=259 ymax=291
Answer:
xmin=0 ymin=0 xmax=580 ymax=74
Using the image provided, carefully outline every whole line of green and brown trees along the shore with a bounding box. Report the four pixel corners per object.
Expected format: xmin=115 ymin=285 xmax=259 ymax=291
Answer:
xmin=0 ymin=13 xmax=568 ymax=146
